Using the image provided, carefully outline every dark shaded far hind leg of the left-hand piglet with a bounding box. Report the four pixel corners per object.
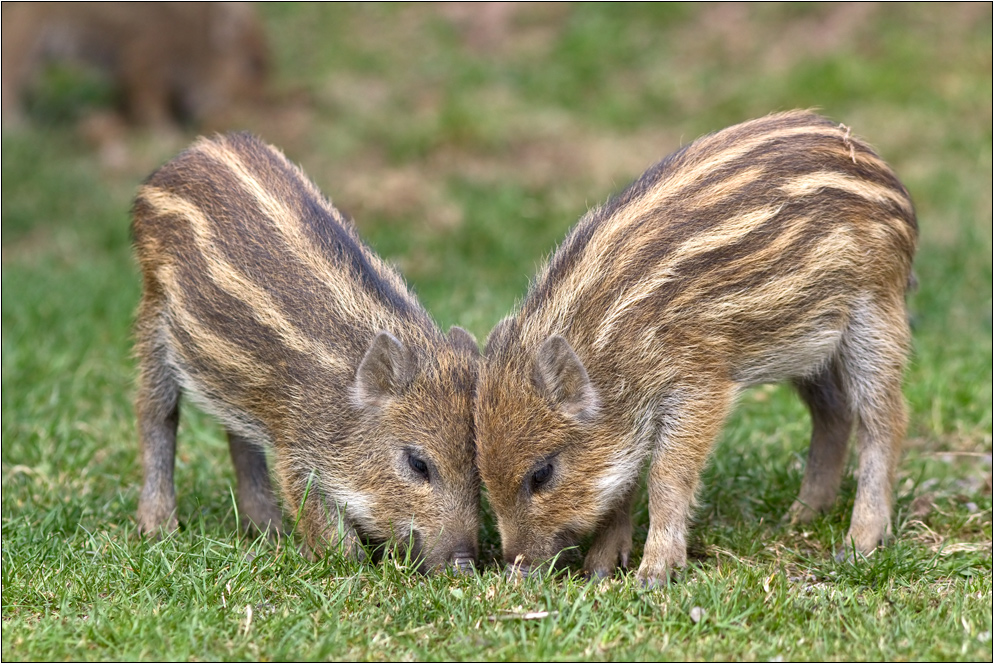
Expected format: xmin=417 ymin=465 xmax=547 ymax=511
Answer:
xmin=228 ymin=431 xmax=283 ymax=537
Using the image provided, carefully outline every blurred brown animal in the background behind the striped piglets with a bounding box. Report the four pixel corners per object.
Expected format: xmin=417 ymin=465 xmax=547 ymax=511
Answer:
xmin=3 ymin=2 xmax=269 ymax=129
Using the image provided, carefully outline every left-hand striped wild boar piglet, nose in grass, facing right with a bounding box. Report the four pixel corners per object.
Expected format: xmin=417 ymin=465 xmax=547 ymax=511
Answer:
xmin=132 ymin=134 xmax=479 ymax=567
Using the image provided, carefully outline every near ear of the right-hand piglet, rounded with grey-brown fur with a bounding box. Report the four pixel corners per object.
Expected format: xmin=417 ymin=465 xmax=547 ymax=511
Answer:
xmin=534 ymin=334 xmax=599 ymax=420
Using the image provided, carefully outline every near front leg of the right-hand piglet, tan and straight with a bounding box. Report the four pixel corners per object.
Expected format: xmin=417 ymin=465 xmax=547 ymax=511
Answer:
xmin=638 ymin=383 xmax=735 ymax=586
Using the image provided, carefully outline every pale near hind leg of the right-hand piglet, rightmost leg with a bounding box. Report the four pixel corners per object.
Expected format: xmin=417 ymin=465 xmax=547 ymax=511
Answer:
xmin=840 ymin=298 xmax=910 ymax=557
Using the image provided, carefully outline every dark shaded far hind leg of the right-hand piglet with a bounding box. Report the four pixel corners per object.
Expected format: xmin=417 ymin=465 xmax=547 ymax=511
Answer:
xmin=787 ymin=362 xmax=853 ymax=524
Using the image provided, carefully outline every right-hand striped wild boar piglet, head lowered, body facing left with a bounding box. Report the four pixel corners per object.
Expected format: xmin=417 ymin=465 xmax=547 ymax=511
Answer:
xmin=476 ymin=111 xmax=917 ymax=583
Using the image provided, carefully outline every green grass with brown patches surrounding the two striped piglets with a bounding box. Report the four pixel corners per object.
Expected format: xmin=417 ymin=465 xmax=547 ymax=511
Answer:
xmin=0 ymin=4 xmax=992 ymax=660
